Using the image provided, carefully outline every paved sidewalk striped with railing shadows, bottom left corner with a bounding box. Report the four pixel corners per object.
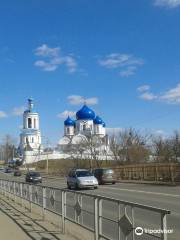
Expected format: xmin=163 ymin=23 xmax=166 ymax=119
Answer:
xmin=0 ymin=195 xmax=74 ymax=240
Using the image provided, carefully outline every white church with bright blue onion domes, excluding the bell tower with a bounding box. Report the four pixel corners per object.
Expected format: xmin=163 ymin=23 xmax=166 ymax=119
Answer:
xmin=58 ymin=104 xmax=110 ymax=158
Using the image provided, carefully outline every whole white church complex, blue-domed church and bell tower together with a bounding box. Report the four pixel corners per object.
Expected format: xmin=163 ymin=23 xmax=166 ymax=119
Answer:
xmin=19 ymin=98 xmax=111 ymax=163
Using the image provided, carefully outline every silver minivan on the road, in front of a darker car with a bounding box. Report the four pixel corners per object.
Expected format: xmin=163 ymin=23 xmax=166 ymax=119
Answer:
xmin=67 ymin=169 xmax=98 ymax=189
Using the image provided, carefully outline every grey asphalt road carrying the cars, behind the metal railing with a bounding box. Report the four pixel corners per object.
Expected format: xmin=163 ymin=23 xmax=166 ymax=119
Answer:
xmin=0 ymin=173 xmax=180 ymax=240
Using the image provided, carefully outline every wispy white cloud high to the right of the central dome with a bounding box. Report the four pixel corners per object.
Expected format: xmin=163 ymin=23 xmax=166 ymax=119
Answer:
xmin=98 ymin=53 xmax=144 ymax=77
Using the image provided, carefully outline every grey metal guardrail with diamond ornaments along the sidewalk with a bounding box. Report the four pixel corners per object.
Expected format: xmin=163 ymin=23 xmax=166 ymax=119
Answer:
xmin=0 ymin=179 xmax=170 ymax=240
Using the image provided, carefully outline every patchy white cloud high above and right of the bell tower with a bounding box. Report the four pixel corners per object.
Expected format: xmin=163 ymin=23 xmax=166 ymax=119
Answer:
xmin=34 ymin=44 xmax=78 ymax=73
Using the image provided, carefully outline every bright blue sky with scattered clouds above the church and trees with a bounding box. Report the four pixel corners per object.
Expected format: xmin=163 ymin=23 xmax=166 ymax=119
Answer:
xmin=0 ymin=0 xmax=180 ymax=143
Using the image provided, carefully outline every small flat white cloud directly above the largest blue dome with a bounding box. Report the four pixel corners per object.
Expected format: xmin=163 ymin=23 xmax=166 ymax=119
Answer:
xmin=67 ymin=95 xmax=98 ymax=105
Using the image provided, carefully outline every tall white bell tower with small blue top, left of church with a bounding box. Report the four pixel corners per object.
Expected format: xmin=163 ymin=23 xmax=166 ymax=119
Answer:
xmin=20 ymin=98 xmax=41 ymax=154
